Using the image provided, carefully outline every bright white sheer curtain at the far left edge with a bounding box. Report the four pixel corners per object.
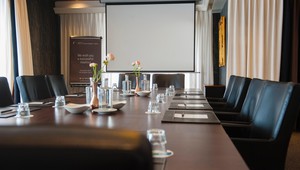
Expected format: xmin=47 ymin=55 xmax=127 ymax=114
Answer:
xmin=0 ymin=0 xmax=13 ymax=90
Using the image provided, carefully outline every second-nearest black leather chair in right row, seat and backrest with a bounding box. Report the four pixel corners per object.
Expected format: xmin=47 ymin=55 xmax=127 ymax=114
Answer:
xmin=215 ymin=78 xmax=267 ymax=123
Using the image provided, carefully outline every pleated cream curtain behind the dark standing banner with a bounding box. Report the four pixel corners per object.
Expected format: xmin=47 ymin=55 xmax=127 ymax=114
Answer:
xmin=60 ymin=13 xmax=106 ymax=91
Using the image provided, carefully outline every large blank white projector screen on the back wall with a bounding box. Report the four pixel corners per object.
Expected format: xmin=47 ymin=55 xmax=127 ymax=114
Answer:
xmin=106 ymin=2 xmax=195 ymax=72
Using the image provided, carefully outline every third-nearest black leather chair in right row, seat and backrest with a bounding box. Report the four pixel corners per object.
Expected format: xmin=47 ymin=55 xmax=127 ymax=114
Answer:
xmin=209 ymin=76 xmax=251 ymax=112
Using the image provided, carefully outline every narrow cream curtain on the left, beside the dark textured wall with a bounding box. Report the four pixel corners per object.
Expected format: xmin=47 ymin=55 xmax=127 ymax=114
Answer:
xmin=14 ymin=0 xmax=33 ymax=75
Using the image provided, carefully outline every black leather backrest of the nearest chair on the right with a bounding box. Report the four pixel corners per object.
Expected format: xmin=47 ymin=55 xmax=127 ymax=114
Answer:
xmin=250 ymin=81 xmax=300 ymax=139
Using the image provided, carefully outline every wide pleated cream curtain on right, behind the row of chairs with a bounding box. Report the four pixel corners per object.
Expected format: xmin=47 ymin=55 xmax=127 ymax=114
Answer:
xmin=227 ymin=0 xmax=283 ymax=81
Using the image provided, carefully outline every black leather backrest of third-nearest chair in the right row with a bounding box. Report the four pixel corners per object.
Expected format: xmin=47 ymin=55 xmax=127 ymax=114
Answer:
xmin=226 ymin=76 xmax=251 ymax=111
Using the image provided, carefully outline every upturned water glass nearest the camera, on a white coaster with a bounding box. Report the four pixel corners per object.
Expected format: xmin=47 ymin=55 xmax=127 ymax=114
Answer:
xmin=147 ymin=129 xmax=167 ymax=154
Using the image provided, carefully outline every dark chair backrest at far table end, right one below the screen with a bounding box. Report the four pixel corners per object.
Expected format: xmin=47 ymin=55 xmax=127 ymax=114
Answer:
xmin=152 ymin=74 xmax=185 ymax=89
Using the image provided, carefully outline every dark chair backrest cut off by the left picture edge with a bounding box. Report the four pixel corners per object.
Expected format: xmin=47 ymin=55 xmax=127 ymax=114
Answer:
xmin=0 ymin=77 xmax=14 ymax=107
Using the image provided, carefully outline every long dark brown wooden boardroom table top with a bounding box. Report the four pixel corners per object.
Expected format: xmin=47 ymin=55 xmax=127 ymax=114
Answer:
xmin=0 ymin=90 xmax=248 ymax=170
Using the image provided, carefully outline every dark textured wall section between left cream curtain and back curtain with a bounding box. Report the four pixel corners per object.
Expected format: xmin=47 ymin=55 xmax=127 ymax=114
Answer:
xmin=27 ymin=0 xmax=60 ymax=75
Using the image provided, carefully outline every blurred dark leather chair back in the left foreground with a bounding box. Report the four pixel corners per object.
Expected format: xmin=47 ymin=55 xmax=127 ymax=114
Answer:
xmin=0 ymin=125 xmax=153 ymax=170
